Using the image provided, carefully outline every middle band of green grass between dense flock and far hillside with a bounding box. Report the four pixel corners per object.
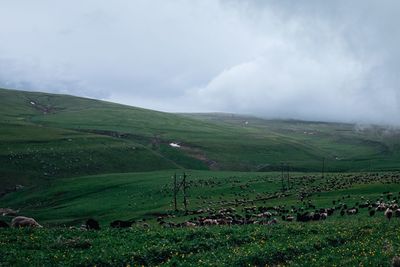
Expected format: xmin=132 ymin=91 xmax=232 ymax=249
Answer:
xmin=0 ymin=170 xmax=400 ymax=225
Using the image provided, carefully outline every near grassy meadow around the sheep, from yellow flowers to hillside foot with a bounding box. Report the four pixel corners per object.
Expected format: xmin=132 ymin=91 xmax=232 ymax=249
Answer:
xmin=0 ymin=170 xmax=400 ymax=266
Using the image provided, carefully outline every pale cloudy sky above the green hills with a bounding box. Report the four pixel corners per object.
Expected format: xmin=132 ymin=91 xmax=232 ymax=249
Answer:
xmin=0 ymin=0 xmax=400 ymax=126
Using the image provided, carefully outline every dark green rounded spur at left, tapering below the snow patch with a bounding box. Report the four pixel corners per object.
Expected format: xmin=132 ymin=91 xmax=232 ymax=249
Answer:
xmin=0 ymin=122 xmax=177 ymax=191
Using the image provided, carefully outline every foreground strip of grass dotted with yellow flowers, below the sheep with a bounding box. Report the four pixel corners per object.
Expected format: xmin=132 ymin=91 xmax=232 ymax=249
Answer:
xmin=0 ymin=218 xmax=400 ymax=266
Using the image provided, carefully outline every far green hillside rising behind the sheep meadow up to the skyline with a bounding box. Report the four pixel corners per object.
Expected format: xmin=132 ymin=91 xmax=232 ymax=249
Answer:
xmin=0 ymin=89 xmax=400 ymax=194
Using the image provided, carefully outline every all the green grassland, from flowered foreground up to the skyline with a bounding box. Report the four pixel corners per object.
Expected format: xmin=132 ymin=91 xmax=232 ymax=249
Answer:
xmin=0 ymin=89 xmax=400 ymax=266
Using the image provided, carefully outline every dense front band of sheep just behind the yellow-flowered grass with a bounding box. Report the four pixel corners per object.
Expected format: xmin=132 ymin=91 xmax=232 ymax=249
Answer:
xmin=0 ymin=192 xmax=400 ymax=230
